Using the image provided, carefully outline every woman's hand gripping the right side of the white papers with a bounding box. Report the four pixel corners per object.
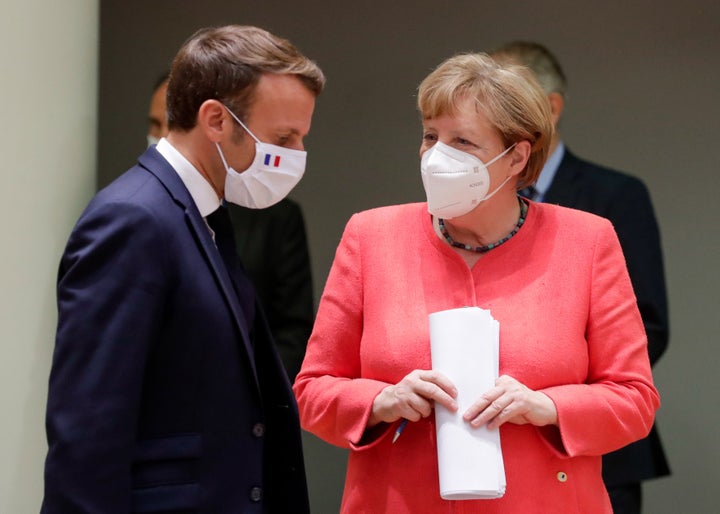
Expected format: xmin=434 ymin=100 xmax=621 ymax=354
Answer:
xmin=463 ymin=375 xmax=558 ymax=429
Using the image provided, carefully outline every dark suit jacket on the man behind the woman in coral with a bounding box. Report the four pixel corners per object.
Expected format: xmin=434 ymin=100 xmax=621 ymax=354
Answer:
xmin=543 ymin=149 xmax=670 ymax=486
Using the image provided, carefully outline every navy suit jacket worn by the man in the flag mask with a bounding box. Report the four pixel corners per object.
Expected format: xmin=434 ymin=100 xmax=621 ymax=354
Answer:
xmin=42 ymin=147 xmax=309 ymax=514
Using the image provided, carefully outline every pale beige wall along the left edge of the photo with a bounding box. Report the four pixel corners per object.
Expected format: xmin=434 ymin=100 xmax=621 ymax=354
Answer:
xmin=0 ymin=0 xmax=98 ymax=514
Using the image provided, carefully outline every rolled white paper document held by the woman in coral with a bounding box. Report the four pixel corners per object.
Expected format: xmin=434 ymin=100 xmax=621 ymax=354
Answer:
xmin=429 ymin=307 xmax=506 ymax=500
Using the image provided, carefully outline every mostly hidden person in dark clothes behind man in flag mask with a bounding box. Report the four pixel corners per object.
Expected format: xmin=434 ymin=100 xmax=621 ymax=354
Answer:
xmin=147 ymin=73 xmax=315 ymax=382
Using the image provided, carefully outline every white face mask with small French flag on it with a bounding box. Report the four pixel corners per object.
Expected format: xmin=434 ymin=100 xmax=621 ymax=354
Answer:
xmin=215 ymin=107 xmax=307 ymax=209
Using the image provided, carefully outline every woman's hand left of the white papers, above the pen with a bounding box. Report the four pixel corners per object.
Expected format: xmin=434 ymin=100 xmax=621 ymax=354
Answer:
xmin=367 ymin=369 xmax=458 ymax=428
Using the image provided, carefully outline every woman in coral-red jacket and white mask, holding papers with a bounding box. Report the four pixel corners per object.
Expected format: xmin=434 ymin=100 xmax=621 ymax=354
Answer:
xmin=293 ymin=54 xmax=660 ymax=514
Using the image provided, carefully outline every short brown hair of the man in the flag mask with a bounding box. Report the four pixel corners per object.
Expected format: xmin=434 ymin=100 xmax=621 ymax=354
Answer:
xmin=167 ymin=25 xmax=325 ymax=131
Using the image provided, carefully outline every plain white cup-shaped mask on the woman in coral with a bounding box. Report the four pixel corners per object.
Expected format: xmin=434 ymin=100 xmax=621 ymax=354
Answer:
xmin=420 ymin=141 xmax=515 ymax=219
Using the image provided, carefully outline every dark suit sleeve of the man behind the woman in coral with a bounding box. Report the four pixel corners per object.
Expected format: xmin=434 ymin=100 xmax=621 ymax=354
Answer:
xmin=607 ymin=178 xmax=669 ymax=364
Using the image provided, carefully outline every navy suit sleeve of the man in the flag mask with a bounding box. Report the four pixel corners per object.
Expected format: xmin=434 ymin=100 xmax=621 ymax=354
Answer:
xmin=42 ymin=204 xmax=168 ymax=514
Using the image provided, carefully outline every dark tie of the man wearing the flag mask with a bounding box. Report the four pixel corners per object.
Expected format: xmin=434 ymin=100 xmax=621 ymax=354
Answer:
xmin=206 ymin=205 xmax=255 ymax=328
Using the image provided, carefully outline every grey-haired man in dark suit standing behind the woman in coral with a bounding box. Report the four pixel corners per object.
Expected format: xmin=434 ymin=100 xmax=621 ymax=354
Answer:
xmin=491 ymin=42 xmax=670 ymax=514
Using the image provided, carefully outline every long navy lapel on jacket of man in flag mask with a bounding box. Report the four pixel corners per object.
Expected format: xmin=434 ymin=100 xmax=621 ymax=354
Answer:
xmin=139 ymin=147 xmax=259 ymax=384
